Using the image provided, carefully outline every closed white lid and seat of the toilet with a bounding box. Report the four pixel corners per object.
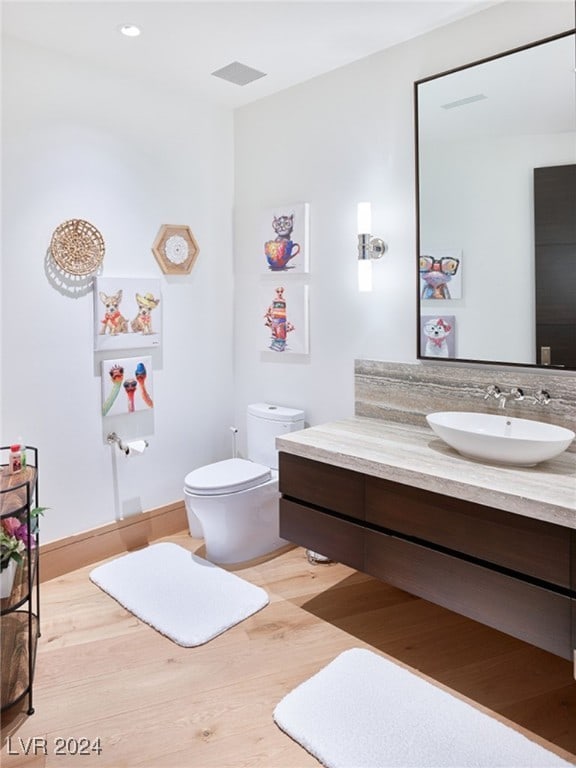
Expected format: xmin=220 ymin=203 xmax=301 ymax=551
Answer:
xmin=184 ymin=459 xmax=272 ymax=496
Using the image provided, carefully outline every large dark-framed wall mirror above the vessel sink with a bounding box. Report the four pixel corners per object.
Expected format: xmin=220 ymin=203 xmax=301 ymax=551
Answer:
xmin=415 ymin=30 xmax=576 ymax=370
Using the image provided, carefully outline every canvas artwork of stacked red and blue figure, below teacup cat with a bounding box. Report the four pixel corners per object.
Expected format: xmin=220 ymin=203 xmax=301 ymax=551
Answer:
xmin=259 ymin=283 xmax=309 ymax=355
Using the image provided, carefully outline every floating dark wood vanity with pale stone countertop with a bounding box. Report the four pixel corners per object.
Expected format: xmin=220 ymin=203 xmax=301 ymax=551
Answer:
xmin=277 ymin=416 xmax=576 ymax=665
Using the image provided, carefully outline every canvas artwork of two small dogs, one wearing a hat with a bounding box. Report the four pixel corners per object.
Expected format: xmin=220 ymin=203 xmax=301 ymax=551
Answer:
xmin=94 ymin=277 xmax=162 ymax=351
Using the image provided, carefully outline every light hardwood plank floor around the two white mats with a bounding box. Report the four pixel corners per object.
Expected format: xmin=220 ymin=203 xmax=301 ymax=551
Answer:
xmin=1 ymin=533 xmax=576 ymax=768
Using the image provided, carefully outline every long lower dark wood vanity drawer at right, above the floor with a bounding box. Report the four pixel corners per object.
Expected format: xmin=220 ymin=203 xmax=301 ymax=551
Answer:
xmin=364 ymin=531 xmax=574 ymax=659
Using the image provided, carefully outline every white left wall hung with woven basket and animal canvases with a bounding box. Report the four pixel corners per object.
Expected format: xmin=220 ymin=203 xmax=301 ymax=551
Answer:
xmin=1 ymin=40 xmax=233 ymax=541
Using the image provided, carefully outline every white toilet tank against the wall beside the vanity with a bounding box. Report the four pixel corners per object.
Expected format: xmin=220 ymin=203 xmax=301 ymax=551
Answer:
xmin=246 ymin=403 xmax=304 ymax=469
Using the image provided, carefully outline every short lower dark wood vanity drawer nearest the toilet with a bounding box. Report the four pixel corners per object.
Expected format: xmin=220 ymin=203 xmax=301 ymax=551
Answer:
xmin=280 ymin=499 xmax=364 ymax=570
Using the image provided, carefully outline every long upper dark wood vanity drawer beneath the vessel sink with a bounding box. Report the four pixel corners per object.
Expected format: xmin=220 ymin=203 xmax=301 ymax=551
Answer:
xmin=366 ymin=477 xmax=576 ymax=588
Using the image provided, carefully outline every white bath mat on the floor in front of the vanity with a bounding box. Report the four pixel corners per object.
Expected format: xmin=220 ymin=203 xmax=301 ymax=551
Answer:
xmin=274 ymin=648 xmax=572 ymax=768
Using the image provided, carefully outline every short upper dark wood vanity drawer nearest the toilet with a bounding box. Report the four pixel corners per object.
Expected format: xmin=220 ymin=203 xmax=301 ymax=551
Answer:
xmin=279 ymin=453 xmax=364 ymax=520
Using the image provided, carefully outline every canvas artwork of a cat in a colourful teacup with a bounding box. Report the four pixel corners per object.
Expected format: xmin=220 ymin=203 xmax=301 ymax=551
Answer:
xmin=258 ymin=203 xmax=310 ymax=274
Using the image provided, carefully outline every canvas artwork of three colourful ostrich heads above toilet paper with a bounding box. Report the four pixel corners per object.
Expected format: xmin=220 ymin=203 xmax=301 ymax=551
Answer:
xmin=102 ymin=357 xmax=154 ymax=417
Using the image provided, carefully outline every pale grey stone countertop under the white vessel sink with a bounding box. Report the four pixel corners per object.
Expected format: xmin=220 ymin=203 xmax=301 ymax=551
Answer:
xmin=276 ymin=416 xmax=576 ymax=529
